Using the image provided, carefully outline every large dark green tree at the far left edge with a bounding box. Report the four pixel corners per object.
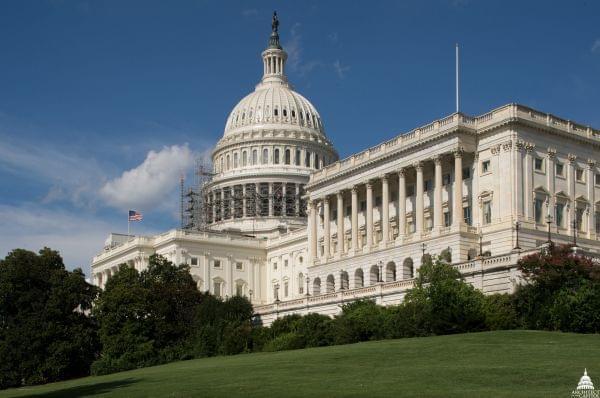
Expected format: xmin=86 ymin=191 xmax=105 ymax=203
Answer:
xmin=0 ymin=248 xmax=99 ymax=388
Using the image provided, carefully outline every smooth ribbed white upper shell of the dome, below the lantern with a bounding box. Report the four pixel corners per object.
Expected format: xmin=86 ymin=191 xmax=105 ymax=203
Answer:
xmin=225 ymin=83 xmax=325 ymax=135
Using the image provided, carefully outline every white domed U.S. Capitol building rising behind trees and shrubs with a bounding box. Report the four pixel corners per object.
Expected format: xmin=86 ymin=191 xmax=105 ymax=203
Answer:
xmin=92 ymin=17 xmax=600 ymax=323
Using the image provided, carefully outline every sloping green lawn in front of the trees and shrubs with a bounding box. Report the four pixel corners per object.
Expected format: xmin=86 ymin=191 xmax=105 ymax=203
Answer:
xmin=0 ymin=331 xmax=600 ymax=398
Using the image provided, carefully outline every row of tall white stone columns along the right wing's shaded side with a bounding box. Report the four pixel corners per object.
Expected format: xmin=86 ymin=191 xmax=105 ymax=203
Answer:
xmin=308 ymin=149 xmax=463 ymax=260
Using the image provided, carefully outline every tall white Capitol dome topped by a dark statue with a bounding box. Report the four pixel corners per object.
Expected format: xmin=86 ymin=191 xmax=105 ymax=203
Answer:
xmin=204 ymin=14 xmax=338 ymax=236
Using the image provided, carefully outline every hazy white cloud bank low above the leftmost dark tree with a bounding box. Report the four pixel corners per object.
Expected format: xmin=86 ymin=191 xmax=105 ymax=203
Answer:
xmin=0 ymin=204 xmax=112 ymax=275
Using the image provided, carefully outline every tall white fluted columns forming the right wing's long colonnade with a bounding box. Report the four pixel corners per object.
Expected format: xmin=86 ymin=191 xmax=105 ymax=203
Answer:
xmin=308 ymin=149 xmax=464 ymax=260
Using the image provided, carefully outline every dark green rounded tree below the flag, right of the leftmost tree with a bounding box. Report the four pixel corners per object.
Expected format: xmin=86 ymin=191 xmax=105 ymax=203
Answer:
xmin=93 ymin=255 xmax=203 ymax=374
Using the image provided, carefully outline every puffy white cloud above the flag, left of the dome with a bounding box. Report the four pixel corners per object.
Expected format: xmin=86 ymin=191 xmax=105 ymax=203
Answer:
xmin=100 ymin=144 xmax=194 ymax=210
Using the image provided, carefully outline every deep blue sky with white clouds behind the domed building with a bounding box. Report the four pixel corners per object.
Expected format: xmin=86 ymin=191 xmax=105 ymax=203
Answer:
xmin=0 ymin=0 xmax=600 ymax=271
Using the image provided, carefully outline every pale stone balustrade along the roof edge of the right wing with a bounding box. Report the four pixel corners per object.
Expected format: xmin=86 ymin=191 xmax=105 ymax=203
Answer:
xmin=309 ymin=104 xmax=600 ymax=185
